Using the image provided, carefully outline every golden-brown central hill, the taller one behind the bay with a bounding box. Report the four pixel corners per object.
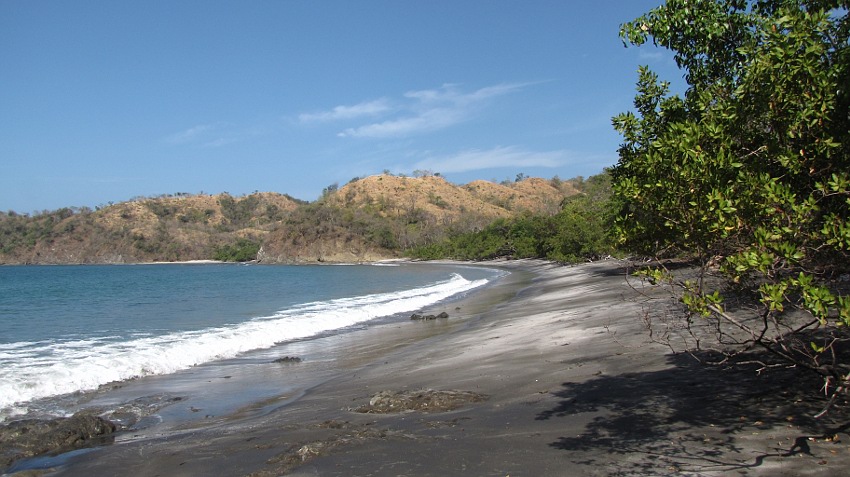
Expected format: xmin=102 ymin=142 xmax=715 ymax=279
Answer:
xmin=260 ymin=175 xmax=576 ymax=262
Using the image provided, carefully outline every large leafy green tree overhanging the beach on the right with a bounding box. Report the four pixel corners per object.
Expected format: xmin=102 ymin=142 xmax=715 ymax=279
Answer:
xmin=612 ymin=0 xmax=850 ymax=410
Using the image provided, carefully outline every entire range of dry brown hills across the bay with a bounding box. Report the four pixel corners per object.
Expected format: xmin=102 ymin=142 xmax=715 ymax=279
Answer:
xmin=0 ymin=175 xmax=576 ymax=264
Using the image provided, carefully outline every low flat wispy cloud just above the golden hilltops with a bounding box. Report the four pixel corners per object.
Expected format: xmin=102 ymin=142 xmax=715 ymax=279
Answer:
xmin=414 ymin=146 xmax=570 ymax=173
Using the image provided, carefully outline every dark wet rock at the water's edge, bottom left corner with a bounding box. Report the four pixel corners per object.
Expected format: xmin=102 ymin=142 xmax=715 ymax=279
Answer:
xmin=0 ymin=411 xmax=116 ymax=471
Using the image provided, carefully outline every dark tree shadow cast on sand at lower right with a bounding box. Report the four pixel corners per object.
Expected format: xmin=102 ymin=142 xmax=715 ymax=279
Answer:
xmin=536 ymin=355 xmax=850 ymax=475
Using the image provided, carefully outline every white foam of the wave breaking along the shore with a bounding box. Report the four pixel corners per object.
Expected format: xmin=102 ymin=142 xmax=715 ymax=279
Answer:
xmin=0 ymin=274 xmax=487 ymax=414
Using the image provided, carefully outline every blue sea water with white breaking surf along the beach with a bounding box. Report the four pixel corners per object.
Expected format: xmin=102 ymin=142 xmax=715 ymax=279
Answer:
xmin=0 ymin=263 xmax=504 ymax=421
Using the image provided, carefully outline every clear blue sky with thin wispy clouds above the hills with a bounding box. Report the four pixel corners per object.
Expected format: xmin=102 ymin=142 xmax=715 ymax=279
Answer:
xmin=0 ymin=0 xmax=681 ymax=213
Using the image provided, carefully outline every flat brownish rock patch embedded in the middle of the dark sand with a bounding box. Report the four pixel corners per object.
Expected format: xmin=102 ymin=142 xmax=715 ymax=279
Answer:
xmin=355 ymin=389 xmax=489 ymax=414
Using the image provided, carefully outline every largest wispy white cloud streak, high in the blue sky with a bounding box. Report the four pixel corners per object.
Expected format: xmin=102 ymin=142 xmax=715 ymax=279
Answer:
xmin=299 ymin=83 xmax=527 ymax=138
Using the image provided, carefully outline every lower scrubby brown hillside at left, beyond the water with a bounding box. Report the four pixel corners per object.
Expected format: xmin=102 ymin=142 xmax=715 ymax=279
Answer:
xmin=0 ymin=193 xmax=299 ymax=263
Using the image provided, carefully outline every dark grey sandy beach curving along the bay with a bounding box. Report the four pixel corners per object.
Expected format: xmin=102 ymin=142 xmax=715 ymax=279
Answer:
xmin=26 ymin=261 xmax=850 ymax=477
